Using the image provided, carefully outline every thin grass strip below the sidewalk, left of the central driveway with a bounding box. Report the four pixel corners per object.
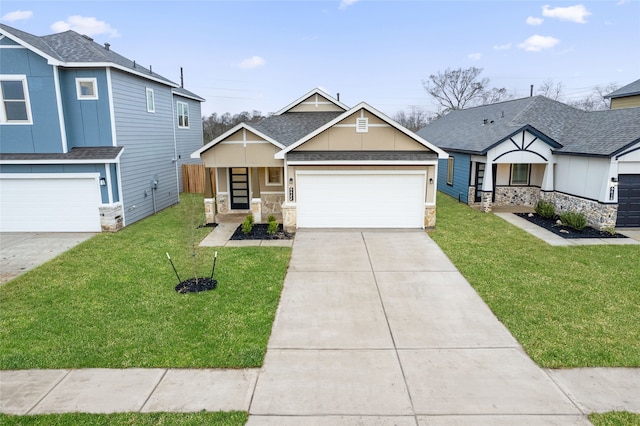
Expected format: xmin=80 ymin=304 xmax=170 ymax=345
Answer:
xmin=0 ymin=411 xmax=248 ymax=426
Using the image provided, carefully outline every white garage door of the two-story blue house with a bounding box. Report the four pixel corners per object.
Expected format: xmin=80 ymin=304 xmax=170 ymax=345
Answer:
xmin=0 ymin=173 xmax=100 ymax=232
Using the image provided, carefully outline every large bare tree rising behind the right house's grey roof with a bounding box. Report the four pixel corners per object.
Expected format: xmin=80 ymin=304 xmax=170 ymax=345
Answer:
xmin=422 ymin=67 xmax=508 ymax=115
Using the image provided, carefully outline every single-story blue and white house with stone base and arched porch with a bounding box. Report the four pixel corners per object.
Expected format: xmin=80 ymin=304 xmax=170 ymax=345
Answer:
xmin=417 ymin=96 xmax=640 ymax=229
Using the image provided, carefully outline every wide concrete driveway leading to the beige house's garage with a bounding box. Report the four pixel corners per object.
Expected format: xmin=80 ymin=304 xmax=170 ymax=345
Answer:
xmin=248 ymin=230 xmax=589 ymax=426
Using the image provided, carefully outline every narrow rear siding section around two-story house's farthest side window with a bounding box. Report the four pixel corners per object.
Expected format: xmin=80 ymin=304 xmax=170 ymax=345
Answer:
xmin=173 ymin=94 xmax=203 ymax=191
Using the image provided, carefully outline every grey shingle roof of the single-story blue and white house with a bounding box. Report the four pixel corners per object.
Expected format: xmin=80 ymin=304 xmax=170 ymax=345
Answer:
xmin=417 ymin=96 xmax=640 ymax=156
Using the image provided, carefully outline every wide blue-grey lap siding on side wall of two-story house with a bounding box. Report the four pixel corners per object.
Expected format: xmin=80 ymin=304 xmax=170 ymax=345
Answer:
xmin=111 ymin=70 xmax=179 ymax=225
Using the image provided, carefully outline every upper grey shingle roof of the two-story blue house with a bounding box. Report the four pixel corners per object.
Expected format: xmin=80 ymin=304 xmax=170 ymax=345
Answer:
xmin=0 ymin=24 xmax=189 ymax=87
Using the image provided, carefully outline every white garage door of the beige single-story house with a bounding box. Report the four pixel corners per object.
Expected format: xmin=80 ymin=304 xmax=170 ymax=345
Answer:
xmin=296 ymin=171 xmax=426 ymax=228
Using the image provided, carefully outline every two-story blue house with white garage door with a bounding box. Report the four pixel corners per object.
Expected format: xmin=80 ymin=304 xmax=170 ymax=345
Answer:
xmin=0 ymin=25 xmax=204 ymax=232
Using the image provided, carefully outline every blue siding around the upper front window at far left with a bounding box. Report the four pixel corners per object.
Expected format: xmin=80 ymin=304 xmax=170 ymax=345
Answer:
xmin=0 ymin=38 xmax=64 ymax=154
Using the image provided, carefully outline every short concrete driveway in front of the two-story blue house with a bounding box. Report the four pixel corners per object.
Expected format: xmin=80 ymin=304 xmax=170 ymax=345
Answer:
xmin=0 ymin=232 xmax=95 ymax=284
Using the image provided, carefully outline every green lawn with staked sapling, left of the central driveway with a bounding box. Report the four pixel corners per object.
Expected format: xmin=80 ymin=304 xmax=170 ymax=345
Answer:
xmin=0 ymin=194 xmax=291 ymax=369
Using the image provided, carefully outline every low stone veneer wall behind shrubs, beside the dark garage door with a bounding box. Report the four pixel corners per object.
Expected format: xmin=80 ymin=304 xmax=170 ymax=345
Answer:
xmin=541 ymin=192 xmax=618 ymax=231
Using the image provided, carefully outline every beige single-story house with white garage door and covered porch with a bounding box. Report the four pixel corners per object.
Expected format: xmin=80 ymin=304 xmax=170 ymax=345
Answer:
xmin=192 ymin=89 xmax=447 ymax=230
